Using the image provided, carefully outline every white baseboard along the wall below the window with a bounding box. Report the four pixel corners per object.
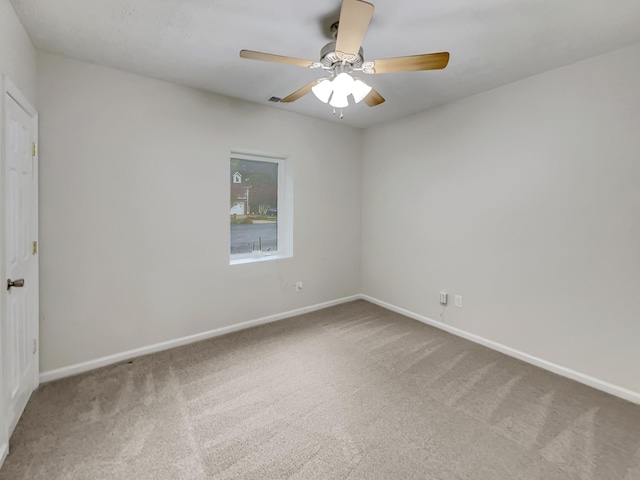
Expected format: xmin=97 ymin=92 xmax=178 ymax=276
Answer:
xmin=40 ymin=295 xmax=361 ymax=383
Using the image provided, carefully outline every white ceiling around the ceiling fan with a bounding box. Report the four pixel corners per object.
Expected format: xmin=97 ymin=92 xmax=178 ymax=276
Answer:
xmin=12 ymin=0 xmax=640 ymax=127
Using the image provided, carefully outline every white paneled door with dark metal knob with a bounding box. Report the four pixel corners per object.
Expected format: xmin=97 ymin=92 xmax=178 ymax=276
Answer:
xmin=0 ymin=85 xmax=38 ymax=435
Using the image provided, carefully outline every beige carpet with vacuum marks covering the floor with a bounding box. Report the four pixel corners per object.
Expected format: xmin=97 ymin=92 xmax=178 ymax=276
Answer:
xmin=0 ymin=301 xmax=640 ymax=480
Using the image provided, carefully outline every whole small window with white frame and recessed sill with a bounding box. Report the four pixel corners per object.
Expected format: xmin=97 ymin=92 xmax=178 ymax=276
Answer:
xmin=229 ymin=153 xmax=291 ymax=264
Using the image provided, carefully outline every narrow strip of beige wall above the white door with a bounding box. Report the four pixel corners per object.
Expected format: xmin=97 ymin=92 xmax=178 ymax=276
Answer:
xmin=0 ymin=0 xmax=36 ymax=105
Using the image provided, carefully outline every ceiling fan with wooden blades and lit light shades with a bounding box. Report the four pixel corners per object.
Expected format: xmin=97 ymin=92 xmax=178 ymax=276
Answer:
xmin=240 ymin=0 xmax=449 ymax=118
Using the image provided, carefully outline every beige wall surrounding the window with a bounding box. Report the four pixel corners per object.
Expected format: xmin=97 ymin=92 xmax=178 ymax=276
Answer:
xmin=38 ymin=54 xmax=362 ymax=372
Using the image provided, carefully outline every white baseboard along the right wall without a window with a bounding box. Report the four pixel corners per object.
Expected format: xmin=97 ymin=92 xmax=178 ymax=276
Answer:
xmin=359 ymin=295 xmax=640 ymax=405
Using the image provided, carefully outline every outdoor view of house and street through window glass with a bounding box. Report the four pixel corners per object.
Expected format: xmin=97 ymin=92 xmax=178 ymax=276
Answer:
xmin=230 ymin=157 xmax=280 ymax=258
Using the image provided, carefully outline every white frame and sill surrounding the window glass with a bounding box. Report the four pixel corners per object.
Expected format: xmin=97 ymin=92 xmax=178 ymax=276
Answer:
xmin=227 ymin=151 xmax=293 ymax=265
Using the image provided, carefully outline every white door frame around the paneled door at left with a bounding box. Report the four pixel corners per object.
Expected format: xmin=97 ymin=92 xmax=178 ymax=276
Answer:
xmin=0 ymin=75 xmax=40 ymax=467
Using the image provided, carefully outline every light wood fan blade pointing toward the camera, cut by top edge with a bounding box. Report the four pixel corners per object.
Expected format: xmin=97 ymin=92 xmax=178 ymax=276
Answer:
xmin=336 ymin=0 xmax=373 ymax=62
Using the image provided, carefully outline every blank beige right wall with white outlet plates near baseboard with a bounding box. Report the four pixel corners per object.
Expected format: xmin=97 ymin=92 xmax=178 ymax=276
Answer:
xmin=362 ymin=45 xmax=640 ymax=392
